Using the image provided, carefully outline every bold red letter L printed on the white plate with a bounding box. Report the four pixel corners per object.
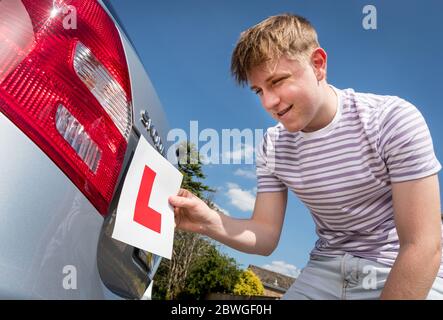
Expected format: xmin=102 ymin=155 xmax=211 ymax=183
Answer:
xmin=134 ymin=166 xmax=161 ymax=233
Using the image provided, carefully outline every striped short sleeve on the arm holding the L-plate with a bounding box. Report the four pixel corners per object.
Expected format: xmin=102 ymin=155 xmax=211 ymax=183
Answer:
xmin=256 ymin=132 xmax=287 ymax=192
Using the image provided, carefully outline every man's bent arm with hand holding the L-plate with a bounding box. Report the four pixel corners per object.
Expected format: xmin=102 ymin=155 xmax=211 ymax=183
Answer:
xmin=169 ymin=191 xmax=288 ymax=255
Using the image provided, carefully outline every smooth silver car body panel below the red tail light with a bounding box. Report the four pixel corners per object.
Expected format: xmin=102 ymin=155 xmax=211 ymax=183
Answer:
xmin=0 ymin=113 xmax=104 ymax=299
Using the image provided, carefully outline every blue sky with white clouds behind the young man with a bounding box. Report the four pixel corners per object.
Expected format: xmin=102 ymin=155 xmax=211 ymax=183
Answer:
xmin=112 ymin=0 xmax=443 ymax=273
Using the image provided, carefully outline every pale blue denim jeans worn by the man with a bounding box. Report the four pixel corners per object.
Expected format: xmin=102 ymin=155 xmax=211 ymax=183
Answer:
xmin=282 ymin=254 xmax=443 ymax=300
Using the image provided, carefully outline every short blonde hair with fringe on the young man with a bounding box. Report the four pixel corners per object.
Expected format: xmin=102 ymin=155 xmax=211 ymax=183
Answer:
xmin=231 ymin=14 xmax=320 ymax=85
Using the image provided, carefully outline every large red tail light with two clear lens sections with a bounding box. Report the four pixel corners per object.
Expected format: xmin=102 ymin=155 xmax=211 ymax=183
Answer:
xmin=0 ymin=0 xmax=132 ymax=215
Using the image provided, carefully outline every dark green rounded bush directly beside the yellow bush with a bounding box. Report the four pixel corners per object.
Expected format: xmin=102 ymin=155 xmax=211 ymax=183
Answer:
xmin=180 ymin=244 xmax=241 ymax=300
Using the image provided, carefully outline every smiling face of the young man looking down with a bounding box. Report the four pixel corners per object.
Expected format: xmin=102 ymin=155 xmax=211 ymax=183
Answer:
xmin=248 ymin=56 xmax=322 ymax=132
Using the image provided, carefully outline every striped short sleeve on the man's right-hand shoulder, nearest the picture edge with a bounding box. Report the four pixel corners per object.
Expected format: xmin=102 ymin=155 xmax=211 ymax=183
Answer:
xmin=379 ymin=97 xmax=441 ymax=182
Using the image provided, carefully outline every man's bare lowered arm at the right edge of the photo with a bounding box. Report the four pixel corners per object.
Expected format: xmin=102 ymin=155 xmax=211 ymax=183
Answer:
xmin=381 ymin=175 xmax=442 ymax=299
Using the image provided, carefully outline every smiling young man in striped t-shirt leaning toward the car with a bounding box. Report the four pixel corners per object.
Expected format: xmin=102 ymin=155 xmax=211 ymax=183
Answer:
xmin=169 ymin=14 xmax=443 ymax=299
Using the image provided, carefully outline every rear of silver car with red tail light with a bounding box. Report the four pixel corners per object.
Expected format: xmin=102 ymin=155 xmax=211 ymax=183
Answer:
xmin=0 ymin=0 xmax=168 ymax=299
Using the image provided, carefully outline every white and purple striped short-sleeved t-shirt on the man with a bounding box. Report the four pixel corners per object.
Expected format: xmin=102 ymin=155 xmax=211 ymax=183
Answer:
xmin=257 ymin=88 xmax=443 ymax=276
